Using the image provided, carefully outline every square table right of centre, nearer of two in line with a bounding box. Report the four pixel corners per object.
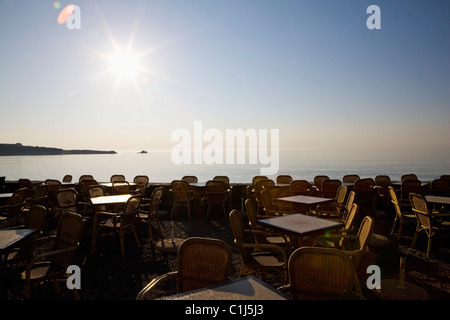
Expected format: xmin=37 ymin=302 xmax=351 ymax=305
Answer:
xmin=257 ymin=213 xmax=343 ymax=248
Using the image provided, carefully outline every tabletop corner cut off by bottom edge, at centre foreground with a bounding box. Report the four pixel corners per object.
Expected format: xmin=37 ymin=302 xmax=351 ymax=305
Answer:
xmin=160 ymin=275 xmax=289 ymax=300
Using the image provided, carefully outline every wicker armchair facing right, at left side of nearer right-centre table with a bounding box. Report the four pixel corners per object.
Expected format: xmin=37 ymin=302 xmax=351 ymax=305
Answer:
xmin=229 ymin=209 xmax=288 ymax=283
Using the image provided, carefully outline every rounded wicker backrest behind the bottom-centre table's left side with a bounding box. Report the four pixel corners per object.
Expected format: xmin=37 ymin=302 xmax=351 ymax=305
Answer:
xmin=177 ymin=237 xmax=232 ymax=292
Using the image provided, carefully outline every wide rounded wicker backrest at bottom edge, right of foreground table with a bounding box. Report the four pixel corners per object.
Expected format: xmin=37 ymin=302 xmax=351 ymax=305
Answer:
xmin=288 ymin=247 xmax=359 ymax=300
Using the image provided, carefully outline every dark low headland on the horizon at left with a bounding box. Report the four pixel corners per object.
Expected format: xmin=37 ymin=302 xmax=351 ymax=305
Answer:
xmin=0 ymin=143 xmax=117 ymax=156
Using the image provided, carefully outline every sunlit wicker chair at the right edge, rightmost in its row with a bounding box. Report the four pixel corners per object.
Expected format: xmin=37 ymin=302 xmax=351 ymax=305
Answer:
xmin=409 ymin=193 xmax=450 ymax=257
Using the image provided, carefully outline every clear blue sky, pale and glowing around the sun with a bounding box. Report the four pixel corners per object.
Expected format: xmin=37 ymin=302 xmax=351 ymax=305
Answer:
xmin=0 ymin=0 xmax=450 ymax=151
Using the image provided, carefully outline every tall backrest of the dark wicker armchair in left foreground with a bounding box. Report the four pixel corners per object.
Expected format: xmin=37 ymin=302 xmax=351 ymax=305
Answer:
xmin=52 ymin=211 xmax=83 ymax=268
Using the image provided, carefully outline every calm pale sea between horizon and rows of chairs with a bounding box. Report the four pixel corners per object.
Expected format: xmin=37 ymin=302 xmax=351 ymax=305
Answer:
xmin=0 ymin=149 xmax=450 ymax=183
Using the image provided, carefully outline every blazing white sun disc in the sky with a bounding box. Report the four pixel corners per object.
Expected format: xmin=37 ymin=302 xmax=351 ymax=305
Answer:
xmin=108 ymin=49 xmax=140 ymax=79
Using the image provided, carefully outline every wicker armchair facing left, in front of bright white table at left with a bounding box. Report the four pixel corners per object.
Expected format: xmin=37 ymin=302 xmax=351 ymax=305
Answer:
xmin=91 ymin=195 xmax=142 ymax=258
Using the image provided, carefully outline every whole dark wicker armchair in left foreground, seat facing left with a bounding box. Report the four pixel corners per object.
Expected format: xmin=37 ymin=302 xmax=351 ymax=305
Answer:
xmin=22 ymin=212 xmax=83 ymax=298
